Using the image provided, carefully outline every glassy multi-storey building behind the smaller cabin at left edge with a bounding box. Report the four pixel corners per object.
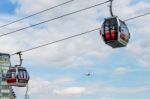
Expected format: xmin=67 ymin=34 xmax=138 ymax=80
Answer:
xmin=0 ymin=53 xmax=15 ymax=99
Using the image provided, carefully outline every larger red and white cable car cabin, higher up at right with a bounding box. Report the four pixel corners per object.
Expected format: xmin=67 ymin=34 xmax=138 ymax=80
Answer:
xmin=100 ymin=17 xmax=130 ymax=48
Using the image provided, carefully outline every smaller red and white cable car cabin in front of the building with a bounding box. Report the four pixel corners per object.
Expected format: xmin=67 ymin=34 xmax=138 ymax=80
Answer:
xmin=6 ymin=66 xmax=29 ymax=87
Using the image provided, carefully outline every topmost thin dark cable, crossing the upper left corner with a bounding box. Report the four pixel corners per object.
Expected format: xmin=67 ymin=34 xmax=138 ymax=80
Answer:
xmin=0 ymin=0 xmax=74 ymax=28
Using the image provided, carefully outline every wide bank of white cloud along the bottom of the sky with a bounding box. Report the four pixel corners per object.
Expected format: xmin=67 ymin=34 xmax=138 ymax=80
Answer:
xmin=15 ymin=77 xmax=150 ymax=99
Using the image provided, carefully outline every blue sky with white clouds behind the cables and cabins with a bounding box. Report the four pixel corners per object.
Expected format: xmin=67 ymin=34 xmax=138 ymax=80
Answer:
xmin=0 ymin=0 xmax=150 ymax=99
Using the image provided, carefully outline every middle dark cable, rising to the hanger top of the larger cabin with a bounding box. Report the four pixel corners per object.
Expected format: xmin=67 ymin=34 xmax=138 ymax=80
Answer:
xmin=0 ymin=1 xmax=109 ymax=37
